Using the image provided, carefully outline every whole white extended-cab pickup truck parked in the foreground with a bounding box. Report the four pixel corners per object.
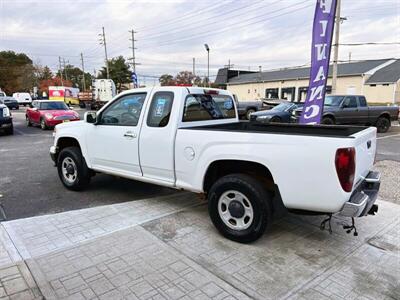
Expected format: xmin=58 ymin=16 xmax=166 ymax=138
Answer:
xmin=50 ymin=87 xmax=380 ymax=242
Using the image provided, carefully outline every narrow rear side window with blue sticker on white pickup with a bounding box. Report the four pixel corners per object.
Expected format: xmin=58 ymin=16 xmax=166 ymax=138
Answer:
xmin=147 ymin=92 xmax=174 ymax=127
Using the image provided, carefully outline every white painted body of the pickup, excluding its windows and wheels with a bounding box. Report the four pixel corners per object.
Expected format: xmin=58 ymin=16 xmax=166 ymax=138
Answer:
xmin=50 ymin=87 xmax=379 ymax=241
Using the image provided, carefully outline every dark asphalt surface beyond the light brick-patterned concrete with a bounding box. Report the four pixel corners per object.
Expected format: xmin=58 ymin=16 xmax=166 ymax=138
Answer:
xmin=0 ymin=108 xmax=400 ymax=220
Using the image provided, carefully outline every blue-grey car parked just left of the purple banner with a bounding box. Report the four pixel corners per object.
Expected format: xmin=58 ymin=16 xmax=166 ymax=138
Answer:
xmin=250 ymin=101 xmax=304 ymax=123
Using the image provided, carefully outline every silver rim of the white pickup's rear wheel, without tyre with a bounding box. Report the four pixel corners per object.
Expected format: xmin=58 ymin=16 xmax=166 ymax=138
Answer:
xmin=218 ymin=190 xmax=254 ymax=230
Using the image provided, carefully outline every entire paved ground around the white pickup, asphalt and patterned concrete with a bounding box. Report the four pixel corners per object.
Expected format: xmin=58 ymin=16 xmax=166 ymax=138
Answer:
xmin=0 ymin=106 xmax=400 ymax=300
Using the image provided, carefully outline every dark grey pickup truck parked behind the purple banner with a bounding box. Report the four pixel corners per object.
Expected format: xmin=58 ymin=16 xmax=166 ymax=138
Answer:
xmin=292 ymin=95 xmax=399 ymax=132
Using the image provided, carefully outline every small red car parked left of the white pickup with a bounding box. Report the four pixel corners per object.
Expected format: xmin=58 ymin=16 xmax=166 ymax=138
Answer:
xmin=26 ymin=100 xmax=80 ymax=130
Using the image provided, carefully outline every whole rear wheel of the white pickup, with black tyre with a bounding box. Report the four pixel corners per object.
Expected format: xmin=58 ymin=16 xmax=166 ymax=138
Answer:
xmin=208 ymin=174 xmax=272 ymax=243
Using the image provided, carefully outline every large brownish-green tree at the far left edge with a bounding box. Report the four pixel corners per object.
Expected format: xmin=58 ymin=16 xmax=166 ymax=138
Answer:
xmin=0 ymin=51 xmax=36 ymax=94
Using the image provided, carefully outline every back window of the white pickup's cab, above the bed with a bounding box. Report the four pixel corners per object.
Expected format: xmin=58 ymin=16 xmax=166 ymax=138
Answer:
xmin=182 ymin=94 xmax=236 ymax=122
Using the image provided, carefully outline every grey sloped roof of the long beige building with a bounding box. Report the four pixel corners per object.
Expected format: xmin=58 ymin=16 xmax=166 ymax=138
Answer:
xmin=228 ymin=59 xmax=400 ymax=84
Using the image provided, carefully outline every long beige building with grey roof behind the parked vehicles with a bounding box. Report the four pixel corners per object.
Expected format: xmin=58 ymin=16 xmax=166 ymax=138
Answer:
xmin=225 ymin=59 xmax=400 ymax=103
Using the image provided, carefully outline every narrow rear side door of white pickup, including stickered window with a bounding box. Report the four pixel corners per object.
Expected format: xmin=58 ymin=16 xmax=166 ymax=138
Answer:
xmin=140 ymin=89 xmax=180 ymax=185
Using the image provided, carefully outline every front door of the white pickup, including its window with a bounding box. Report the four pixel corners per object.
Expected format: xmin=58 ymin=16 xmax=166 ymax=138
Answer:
xmin=86 ymin=92 xmax=147 ymax=177
